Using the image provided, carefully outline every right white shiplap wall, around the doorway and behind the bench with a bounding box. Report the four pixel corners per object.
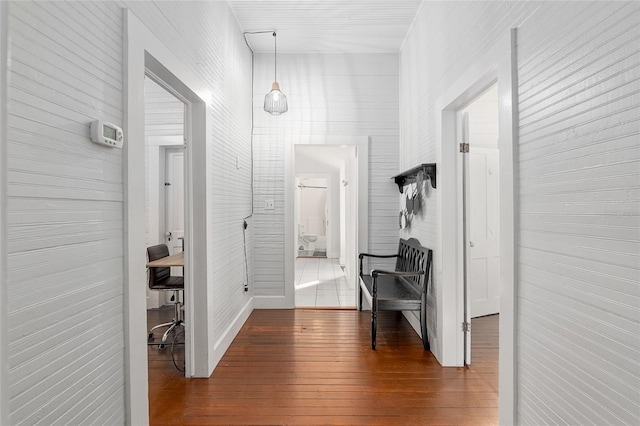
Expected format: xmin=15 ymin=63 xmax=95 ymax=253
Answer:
xmin=400 ymin=2 xmax=640 ymax=425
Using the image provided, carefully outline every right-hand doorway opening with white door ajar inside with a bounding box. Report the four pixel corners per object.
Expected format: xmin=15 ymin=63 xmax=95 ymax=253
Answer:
xmin=458 ymin=84 xmax=500 ymax=365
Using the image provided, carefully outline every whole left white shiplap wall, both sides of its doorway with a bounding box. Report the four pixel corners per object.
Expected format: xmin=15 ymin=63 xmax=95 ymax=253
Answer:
xmin=7 ymin=1 xmax=251 ymax=425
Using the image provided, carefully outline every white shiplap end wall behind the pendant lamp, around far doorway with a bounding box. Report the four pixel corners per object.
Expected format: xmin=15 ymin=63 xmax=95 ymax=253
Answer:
xmin=254 ymin=54 xmax=398 ymax=296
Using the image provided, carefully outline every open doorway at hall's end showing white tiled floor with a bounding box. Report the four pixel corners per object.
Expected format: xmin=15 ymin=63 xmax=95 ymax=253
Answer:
xmin=294 ymin=145 xmax=357 ymax=308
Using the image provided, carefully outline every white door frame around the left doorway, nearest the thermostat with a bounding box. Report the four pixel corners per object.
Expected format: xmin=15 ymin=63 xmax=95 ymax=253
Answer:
xmin=123 ymin=9 xmax=211 ymax=425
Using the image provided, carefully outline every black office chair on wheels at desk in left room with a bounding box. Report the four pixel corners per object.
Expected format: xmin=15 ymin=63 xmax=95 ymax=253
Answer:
xmin=147 ymin=244 xmax=184 ymax=349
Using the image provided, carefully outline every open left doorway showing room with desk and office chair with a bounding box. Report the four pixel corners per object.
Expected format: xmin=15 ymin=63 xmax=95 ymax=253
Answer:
xmin=144 ymin=76 xmax=186 ymax=377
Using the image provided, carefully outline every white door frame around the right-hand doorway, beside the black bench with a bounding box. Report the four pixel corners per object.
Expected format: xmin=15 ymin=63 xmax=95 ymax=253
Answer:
xmin=436 ymin=29 xmax=518 ymax=424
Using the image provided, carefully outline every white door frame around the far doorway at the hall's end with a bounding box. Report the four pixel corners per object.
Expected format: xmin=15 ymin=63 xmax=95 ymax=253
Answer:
xmin=284 ymin=136 xmax=369 ymax=309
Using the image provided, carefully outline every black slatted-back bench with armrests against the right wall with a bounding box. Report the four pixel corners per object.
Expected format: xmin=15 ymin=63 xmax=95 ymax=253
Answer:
xmin=358 ymin=238 xmax=433 ymax=350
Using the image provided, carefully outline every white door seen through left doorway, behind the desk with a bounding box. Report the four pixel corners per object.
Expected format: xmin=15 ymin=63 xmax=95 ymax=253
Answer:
xmin=164 ymin=149 xmax=184 ymax=276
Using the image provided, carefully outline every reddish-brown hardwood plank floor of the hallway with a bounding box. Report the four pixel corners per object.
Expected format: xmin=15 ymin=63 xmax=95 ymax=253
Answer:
xmin=149 ymin=309 xmax=498 ymax=425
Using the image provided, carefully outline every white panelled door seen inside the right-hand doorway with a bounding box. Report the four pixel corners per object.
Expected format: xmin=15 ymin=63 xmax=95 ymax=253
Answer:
xmin=467 ymin=146 xmax=500 ymax=318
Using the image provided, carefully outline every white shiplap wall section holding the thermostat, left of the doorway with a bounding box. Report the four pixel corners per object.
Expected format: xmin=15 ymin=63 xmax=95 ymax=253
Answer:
xmin=6 ymin=2 xmax=124 ymax=424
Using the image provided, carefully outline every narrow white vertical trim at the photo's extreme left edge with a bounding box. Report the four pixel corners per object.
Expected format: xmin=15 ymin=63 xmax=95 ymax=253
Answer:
xmin=0 ymin=1 xmax=9 ymax=425
